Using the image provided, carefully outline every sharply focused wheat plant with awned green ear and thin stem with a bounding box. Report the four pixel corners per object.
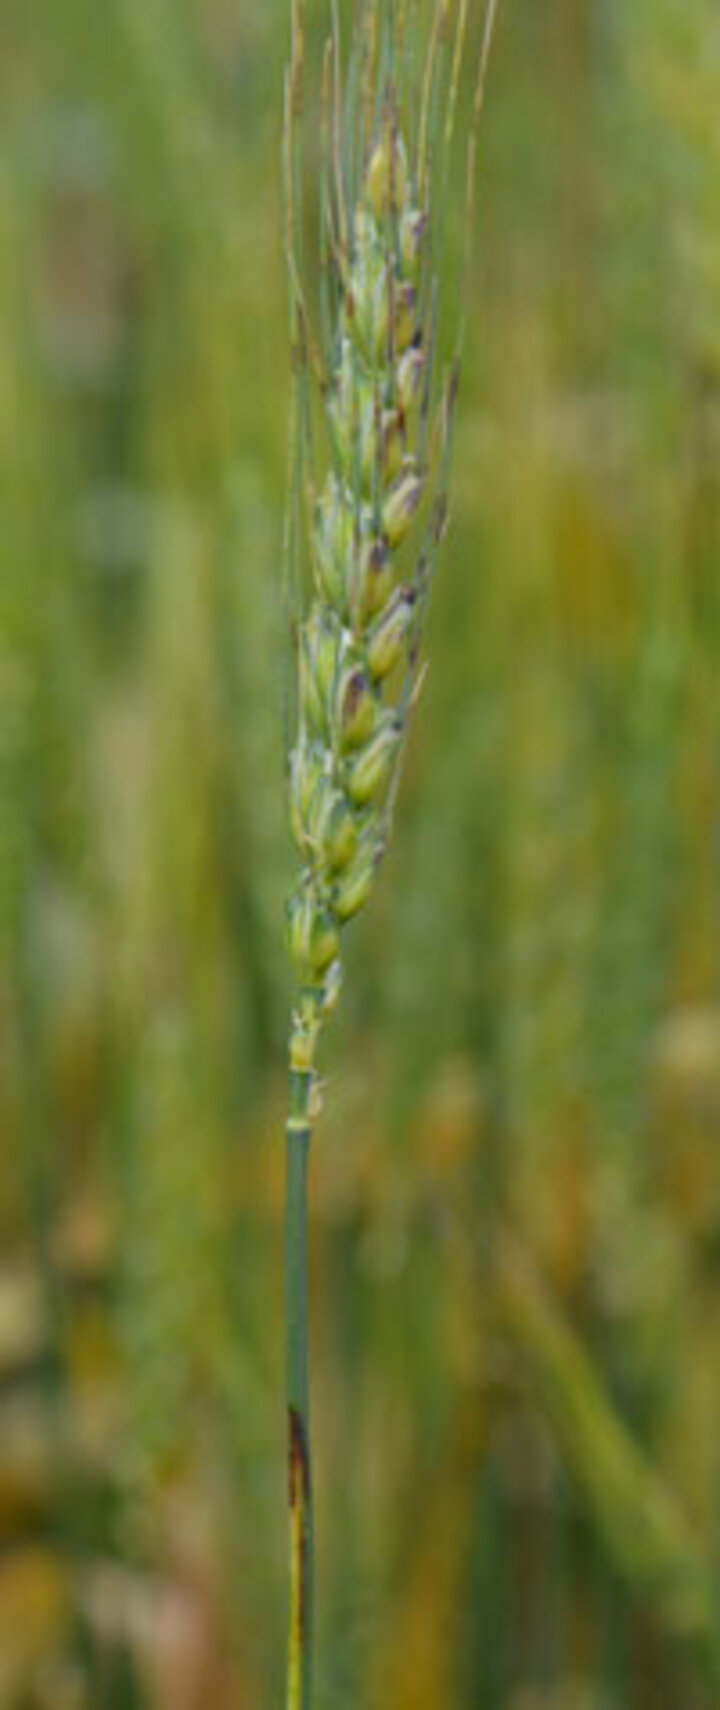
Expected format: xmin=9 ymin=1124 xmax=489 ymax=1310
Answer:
xmin=286 ymin=0 xmax=496 ymax=1710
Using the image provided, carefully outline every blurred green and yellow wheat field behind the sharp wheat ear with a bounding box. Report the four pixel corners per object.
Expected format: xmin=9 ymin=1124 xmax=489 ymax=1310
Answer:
xmin=0 ymin=0 xmax=720 ymax=1710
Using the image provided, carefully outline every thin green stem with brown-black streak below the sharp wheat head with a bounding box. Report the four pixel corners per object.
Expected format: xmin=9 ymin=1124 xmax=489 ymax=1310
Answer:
xmin=286 ymin=1046 xmax=315 ymax=1710
